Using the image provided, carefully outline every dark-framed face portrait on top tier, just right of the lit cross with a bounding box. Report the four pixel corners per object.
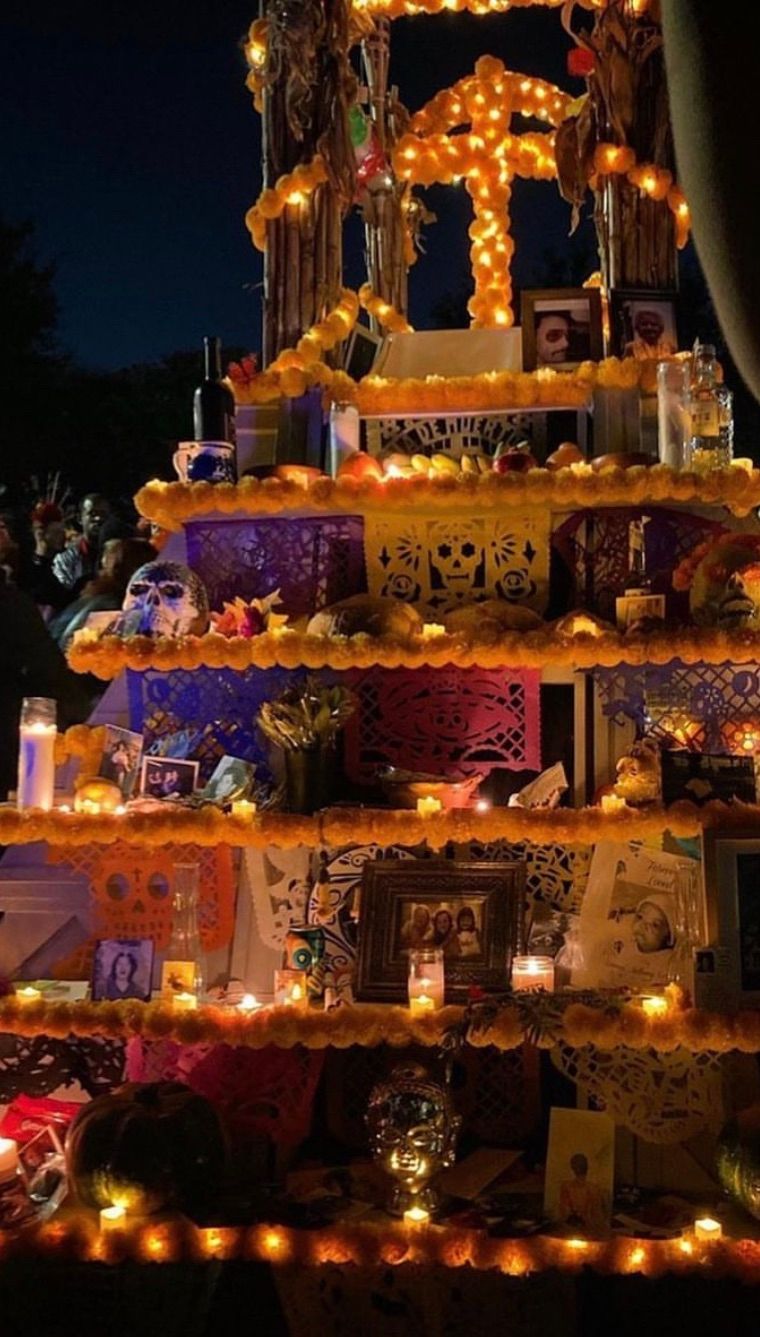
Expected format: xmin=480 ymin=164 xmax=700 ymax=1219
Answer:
xmin=520 ymin=287 xmax=603 ymax=372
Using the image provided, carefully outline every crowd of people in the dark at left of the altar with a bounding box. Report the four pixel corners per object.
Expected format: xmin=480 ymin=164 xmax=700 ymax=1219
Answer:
xmin=0 ymin=492 xmax=155 ymax=800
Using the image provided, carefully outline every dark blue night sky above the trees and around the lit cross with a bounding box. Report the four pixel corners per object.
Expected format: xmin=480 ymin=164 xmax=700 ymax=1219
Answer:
xmin=0 ymin=0 xmax=590 ymax=368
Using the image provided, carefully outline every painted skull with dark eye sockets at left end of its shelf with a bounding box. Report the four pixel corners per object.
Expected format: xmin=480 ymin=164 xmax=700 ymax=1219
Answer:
xmin=120 ymin=562 xmax=209 ymax=636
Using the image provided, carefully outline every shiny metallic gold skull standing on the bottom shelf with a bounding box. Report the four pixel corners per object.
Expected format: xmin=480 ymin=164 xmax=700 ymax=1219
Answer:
xmin=367 ymin=1063 xmax=462 ymax=1217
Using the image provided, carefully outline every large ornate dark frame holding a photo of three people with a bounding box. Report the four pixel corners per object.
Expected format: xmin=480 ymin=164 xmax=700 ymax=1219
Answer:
xmin=356 ymin=858 xmax=525 ymax=1003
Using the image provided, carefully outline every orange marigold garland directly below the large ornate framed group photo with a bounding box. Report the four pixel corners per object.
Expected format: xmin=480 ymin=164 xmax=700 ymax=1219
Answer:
xmin=0 ymin=995 xmax=760 ymax=1054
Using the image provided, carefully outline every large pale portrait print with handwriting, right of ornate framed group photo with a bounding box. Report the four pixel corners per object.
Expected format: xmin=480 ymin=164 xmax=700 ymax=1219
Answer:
xmin=573 ymin=841 xmax=701 ymax=991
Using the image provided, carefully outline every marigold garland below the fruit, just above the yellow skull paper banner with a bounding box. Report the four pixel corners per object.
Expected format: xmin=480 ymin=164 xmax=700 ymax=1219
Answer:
xmin=135 ymin=464 xmax=760 ymax=529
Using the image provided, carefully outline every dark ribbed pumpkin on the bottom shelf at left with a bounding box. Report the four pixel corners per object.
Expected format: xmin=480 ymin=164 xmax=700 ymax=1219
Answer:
xmin=66 ymin=1082 xmax=226 ymax=1217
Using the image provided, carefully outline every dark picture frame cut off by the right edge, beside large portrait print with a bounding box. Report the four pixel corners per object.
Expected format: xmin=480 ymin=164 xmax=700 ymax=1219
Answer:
xmin=697 ymin=829 xmax=760 ymax=1007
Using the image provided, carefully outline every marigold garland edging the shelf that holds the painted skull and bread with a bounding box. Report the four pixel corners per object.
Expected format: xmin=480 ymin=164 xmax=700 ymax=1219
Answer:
xmin=68 ymin=626 xmax=760 ymax=681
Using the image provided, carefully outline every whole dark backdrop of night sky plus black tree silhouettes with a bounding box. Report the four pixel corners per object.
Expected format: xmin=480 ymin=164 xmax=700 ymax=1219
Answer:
xmin=0 ymin=0 xmax=753 ymax=493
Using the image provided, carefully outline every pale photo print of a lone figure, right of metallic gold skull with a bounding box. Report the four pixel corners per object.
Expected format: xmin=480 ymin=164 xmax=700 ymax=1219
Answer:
xmin=543 ymin=1108 xmax=615 ymax=1239
